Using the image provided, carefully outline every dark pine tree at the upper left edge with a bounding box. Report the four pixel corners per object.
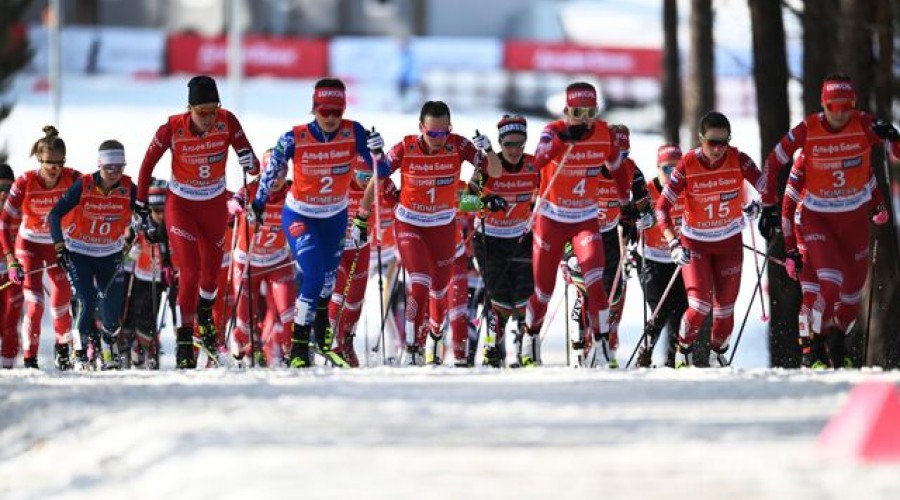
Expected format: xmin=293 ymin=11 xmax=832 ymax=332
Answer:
xmin=0 ymin=0 xmax=32 ymax=162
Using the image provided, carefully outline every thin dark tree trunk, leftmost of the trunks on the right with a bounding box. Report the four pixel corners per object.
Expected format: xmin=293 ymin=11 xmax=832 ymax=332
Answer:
xmin=662 ymin=0 xmax=684 ymax=144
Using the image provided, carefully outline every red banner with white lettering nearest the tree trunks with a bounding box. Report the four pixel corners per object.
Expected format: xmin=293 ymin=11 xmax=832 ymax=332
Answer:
xmin=504 ymin=40 xmax=662 ymax=78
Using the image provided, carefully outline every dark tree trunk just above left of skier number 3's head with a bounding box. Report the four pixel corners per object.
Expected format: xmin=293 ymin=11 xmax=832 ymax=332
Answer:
xmin=803 ymin=0 xmax=840 ymax=115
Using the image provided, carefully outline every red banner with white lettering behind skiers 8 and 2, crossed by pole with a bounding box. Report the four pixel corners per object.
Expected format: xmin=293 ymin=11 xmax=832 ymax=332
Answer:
xmin=167 ymin=35 xmax=328 ymax=78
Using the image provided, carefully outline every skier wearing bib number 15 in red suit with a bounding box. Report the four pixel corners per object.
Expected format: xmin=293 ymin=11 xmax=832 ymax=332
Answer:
xmin=656 ymin=111 xmax=765 ymax=368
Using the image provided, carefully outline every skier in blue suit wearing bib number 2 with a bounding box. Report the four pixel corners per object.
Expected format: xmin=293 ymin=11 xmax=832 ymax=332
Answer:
xmin=251 ymin=78 xmax=384 ymax=368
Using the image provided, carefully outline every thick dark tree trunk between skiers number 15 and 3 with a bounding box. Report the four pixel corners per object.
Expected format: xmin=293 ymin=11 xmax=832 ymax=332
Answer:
xmin=748 ymin=0 xmax=801 ymax=367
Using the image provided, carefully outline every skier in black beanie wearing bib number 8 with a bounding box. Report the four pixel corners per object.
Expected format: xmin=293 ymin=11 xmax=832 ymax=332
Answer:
xmin=137 ymin=76 xmax=259 ymax=369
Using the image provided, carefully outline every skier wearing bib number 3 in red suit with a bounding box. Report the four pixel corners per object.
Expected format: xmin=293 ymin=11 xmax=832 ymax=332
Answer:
xmin=760 ymin=75 xmax=900 ymax=365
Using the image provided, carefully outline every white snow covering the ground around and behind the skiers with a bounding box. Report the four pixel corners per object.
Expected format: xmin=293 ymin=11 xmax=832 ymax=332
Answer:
xmin=0 ymin=77 xmax=900 ymax=499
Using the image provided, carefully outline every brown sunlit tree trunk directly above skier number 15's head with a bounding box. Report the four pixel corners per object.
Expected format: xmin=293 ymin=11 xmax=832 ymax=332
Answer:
xmin=687 ymin=0 xmax=716 ymax=147
